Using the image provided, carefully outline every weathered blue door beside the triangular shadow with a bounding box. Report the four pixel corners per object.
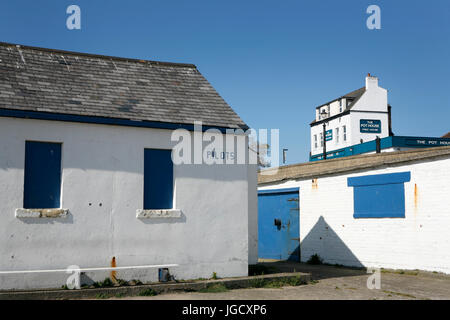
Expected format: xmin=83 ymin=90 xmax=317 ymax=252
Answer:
xmin=258 ymin=188 xmax=300 ymax=261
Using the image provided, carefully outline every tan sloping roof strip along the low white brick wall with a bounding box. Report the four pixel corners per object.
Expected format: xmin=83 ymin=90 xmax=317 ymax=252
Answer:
xmin=258 ymin=146 xmax=450 ymax=185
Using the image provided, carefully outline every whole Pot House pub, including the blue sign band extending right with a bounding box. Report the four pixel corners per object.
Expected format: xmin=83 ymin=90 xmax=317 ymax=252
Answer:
xmin=310 ymin=74 xmax=450 ymax=161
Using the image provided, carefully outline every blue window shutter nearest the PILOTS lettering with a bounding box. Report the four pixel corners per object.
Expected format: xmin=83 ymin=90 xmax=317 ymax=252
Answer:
xmin=144 ymin=149 xmax=173 ymax=209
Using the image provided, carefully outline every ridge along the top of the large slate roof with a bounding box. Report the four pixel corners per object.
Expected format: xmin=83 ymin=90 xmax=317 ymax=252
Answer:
xmin=0 ymin=41 xmax=197 ymax=69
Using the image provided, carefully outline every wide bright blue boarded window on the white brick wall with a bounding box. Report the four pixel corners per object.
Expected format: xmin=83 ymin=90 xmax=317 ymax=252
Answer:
xmin=347 ymin=171 xmax=411 ymax=218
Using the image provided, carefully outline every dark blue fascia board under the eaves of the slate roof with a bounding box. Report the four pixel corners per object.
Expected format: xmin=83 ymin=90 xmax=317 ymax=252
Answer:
xmin=0 ymin=109 xmax=248 ymax=133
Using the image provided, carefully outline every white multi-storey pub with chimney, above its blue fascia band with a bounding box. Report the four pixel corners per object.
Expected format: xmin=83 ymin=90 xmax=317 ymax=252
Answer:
xmin=310 ymin=74 xmax=391 ymax=160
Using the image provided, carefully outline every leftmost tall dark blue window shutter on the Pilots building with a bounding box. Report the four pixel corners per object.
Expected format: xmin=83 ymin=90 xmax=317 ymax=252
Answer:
xmin=23 ymin=141 xmax=61 ymax=209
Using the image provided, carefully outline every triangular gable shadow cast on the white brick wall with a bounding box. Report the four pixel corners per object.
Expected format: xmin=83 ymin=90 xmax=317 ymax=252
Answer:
xmin=300 ymin=216 xmax=363 ymax=267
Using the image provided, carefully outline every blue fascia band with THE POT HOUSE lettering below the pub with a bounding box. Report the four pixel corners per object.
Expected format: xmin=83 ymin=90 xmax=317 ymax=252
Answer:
xmin=309 ymin=136 xmax=450 ymax=161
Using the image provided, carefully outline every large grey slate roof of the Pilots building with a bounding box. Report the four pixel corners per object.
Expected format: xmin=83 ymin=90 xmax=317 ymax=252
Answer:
xmin=0 ymin=42 xmax=247 ymax=128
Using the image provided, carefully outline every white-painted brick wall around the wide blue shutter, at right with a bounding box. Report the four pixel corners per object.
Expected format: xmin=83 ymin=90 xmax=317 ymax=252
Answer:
xmin=259 ymin=158 xmax=450 ymax=274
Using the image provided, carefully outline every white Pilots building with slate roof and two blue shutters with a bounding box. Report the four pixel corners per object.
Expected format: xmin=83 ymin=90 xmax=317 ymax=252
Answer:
xmin=0 ymin=43 xmax=257 ymax=290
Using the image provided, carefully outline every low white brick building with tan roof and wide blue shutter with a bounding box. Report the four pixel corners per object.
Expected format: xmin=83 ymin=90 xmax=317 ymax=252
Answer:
xmin=258 ymin=147 xmax=450 ymax=274
